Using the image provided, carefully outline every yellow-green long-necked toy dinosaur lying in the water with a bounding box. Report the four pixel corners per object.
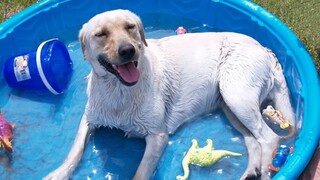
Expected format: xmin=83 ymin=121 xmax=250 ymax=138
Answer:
xmin=177 ymin=139 xmax=242 ymax=180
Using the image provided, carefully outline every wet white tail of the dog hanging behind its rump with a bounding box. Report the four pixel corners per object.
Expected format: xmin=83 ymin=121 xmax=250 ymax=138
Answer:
xmin=270 ymin=51 xmax=295 ymax=138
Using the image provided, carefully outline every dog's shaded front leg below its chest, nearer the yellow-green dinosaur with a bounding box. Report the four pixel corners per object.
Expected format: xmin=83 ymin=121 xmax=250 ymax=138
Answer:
xmin=133 ymin=133 xmax=168 ymax=180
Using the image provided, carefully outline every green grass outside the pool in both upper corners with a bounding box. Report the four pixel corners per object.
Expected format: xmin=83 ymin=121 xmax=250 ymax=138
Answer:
xmin=0 ymin=0 xmax=320 ymax=72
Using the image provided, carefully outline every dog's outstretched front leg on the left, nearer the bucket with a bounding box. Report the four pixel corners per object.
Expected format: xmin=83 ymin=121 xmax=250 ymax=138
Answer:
xmin=43 ymin=113 xmax=90 ymax=180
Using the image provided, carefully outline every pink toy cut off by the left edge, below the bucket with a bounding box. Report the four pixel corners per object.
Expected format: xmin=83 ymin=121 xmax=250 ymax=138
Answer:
xmin=0 ymin=112 xmax=14 ymax=153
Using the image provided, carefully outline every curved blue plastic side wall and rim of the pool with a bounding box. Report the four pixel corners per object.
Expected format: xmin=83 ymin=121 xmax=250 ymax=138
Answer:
xmin=0 ymin=0 xmax=320 ymax=179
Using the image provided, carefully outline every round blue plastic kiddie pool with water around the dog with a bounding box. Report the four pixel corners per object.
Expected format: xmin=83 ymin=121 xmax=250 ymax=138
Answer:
xmin=0 ymin=0 xmax=320 ymax=180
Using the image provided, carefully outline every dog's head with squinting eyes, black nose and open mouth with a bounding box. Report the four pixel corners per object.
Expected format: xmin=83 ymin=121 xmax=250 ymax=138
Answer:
xmin=79 ymin=10 xmax=147 ymax=86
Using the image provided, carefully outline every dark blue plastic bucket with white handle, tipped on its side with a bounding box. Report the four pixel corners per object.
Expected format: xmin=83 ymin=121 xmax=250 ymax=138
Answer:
xmin=4 ymin=39 xmax=72 ymax=95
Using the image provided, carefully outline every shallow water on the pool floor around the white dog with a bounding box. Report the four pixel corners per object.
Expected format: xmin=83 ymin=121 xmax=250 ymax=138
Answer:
xmin=0 ymin=17 xmax=298 ymax=180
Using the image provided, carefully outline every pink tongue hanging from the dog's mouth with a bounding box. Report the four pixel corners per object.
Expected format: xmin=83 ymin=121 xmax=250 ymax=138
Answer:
xmin=116 ymin=62 xmax=140 ymax=83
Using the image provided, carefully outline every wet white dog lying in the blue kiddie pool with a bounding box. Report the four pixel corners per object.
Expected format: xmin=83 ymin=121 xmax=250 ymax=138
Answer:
xmin=46 ymin=10 xmax=294 ymax=179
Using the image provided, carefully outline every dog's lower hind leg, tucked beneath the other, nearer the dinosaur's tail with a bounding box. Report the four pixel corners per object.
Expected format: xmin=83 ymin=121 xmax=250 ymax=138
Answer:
xmin=222 ymin=104 xmax=261 ymax=179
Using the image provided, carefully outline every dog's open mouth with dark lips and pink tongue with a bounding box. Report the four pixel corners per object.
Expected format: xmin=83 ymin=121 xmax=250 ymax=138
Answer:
xmin=98 ymin=56 xmax=140 ymax=86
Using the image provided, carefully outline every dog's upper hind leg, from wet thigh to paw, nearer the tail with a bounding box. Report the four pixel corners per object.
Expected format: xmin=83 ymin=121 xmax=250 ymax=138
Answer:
xmin=220 ymin=85 xmax=280 ymax=179
